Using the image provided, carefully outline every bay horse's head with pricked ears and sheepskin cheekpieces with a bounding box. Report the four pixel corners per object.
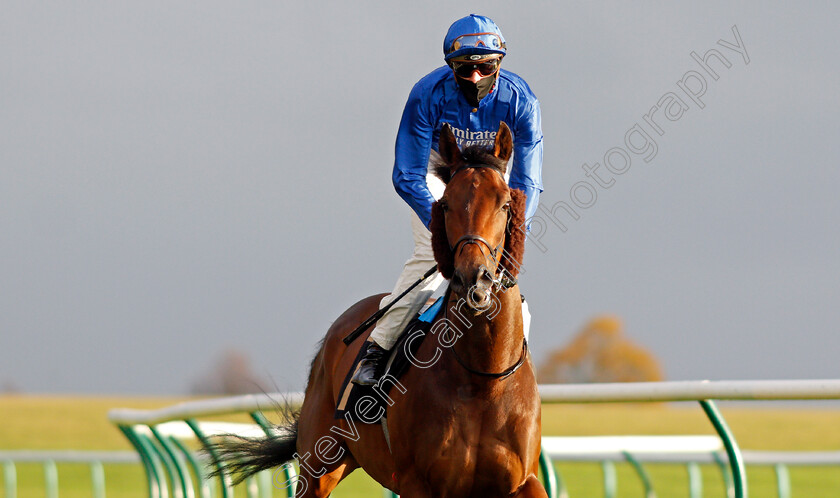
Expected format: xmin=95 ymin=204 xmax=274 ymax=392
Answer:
xmin=430 ymin=123 xmax=525 ymax=310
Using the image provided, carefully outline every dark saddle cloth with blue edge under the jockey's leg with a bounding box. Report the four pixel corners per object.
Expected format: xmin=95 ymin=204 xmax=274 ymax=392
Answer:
xmin=335 ymin=296 xmax=445 ymax=424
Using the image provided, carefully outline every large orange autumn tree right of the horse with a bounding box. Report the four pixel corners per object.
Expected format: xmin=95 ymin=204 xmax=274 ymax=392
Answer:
xmin=537 ymin=316 xmax=664 ymax=384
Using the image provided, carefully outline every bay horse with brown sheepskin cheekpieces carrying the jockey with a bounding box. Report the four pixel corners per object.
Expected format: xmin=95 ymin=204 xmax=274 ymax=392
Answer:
xmin=216 ymin=123 xmax=547 ymax=498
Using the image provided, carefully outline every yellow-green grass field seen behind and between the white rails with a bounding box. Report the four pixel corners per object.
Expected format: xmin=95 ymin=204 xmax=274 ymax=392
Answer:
xmin=0 ymin=396 xmax=840 ymax=498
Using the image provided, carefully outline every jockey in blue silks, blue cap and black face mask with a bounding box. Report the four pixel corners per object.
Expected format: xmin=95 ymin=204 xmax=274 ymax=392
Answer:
xmin=352 ymin=14 xmax=543 ymax=385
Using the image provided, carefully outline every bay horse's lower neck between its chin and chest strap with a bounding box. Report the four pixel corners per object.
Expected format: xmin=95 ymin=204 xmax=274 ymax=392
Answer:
xmin=450 ymin=286 xmax=524 ymax=372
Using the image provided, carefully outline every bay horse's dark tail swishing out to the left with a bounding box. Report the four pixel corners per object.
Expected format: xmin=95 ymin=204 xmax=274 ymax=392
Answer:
xmin=208 ymin=406 xmax=300 ymax=484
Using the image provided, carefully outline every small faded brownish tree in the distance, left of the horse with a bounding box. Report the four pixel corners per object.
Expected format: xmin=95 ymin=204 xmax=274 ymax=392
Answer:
xmin=192 ymin=349 xmax=266 ymax=395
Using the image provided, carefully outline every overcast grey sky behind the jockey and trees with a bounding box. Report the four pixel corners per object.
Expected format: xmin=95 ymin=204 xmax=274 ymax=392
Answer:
xmin=0 ymin=0 xmax=840 ymax=394
